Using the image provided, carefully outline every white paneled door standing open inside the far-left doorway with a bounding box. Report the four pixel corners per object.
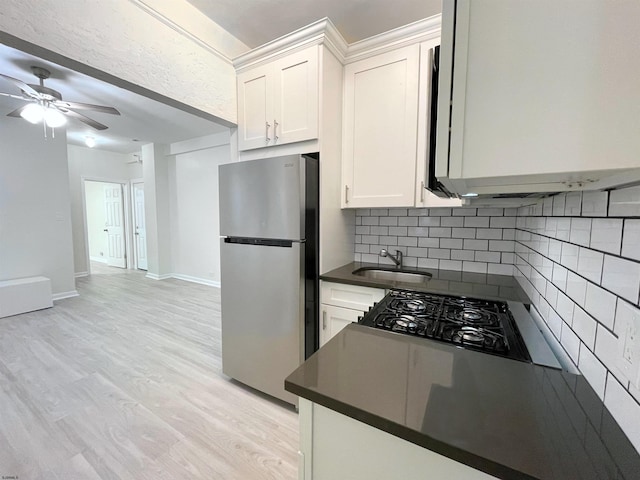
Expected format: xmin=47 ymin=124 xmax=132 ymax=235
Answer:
xmin=104 ymin=183 xmax=127 ymax=268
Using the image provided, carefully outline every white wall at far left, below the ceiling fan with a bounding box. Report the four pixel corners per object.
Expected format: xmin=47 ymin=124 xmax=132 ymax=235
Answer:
xmin=0 ymin=116 xmax=76 ymax=297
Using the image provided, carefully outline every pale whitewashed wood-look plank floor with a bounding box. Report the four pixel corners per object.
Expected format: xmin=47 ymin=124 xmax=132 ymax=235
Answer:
xmin=0 ymin=265 xmax=298 ymax=480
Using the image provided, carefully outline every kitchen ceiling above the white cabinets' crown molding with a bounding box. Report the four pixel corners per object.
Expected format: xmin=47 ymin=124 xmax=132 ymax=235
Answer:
xmin=188 ymin=0 xmax=442 ymax=48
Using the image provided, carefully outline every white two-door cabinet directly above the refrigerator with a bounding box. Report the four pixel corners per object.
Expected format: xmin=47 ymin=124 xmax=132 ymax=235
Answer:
xmin=238 ymin=45 xmax=319 ymax=150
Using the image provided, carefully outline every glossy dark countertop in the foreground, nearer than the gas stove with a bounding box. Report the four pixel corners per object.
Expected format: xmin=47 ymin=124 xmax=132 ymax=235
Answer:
xmin=285 ymin=324 xmax=640 ymax=480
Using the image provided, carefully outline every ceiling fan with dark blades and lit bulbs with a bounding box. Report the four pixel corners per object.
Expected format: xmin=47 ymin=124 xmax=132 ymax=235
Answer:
xmin=0 ymin=67 xmax=120 ymax=130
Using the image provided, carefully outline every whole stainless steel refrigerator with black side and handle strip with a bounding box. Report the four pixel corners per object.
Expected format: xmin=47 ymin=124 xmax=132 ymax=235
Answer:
xmin=219 ymin=154 xmax=318 ymax=404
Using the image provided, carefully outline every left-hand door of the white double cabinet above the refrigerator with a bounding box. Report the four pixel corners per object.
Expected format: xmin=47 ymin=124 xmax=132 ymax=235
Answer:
xmin=238 ymin=67 xmax=273 ymax=150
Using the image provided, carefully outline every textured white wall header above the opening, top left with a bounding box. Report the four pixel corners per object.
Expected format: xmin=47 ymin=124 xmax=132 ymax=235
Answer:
xmin=0 ymin=0 xmax=247 ymax=123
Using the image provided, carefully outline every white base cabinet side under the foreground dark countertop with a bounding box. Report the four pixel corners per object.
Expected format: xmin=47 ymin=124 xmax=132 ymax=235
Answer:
xmin=298 ymin=398 xmax=496 ymax=480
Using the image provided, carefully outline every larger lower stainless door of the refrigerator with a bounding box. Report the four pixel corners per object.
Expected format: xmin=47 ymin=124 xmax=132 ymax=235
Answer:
xmin=220 ymin=239 xmax=304 ymax=404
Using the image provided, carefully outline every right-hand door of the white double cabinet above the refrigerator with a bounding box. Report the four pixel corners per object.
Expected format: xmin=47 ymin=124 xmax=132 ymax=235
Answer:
xmin=271 ymin=46 xmax=319 ymax=145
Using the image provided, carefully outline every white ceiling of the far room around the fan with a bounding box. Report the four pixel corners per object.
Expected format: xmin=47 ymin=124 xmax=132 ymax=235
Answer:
xmin=0 ymin=44 xmax=227 ymax=153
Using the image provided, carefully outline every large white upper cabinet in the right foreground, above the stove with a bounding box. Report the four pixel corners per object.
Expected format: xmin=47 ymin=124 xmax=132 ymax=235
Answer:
xmin=436 ymin=0 xmax=640 ymax=194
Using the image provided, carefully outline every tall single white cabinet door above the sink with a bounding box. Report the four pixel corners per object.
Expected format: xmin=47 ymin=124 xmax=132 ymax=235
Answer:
xmin=342 ymin=44 xmax=420 ymax=207
